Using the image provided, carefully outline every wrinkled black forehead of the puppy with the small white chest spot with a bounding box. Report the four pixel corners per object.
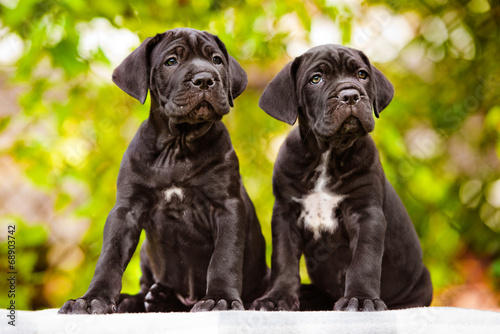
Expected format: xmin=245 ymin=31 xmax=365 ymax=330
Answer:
xmin=152 ymin=28 xmax=222 ymax=66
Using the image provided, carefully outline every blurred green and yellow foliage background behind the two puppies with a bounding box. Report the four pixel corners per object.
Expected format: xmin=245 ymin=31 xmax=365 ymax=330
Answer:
xmin=0 ymin=0 xmax=500 ymax=310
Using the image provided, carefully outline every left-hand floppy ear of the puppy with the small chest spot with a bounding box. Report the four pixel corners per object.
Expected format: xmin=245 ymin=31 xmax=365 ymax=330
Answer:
xmin=113 ymin=34 xmax=163 ymax=104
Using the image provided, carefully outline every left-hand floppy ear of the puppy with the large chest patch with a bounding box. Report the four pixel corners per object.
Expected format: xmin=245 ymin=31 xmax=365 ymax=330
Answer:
xmin=259 ymin=57 xmax=300 ymax=125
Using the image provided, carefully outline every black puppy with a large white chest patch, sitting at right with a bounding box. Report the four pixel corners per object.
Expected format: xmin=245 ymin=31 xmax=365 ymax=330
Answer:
xmin=253 ymin=45 xmax=432 ymax=311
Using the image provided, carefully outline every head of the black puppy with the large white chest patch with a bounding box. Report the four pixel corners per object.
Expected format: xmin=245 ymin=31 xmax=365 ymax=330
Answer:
xmin=259 ymin=45 xmax=394 ymax=147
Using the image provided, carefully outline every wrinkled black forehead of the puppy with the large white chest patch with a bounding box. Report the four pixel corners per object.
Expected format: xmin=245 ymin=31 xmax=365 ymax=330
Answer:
xmin=299 ymin=45 xmax=369 ymax=75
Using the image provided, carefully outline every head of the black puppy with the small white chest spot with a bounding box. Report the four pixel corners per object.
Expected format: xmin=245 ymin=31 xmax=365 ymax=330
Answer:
xmin=113 ymin=28 xmax=247 ymax=124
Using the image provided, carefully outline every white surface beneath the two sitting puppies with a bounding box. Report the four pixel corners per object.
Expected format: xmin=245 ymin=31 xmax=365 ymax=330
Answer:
xmin=0 ymin=307 xmax=500 ymax=334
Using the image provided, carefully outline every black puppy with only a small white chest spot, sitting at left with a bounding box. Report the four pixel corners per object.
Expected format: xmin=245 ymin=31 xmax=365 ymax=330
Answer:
xmin=59 ymin=29 xmax=268 ymax=313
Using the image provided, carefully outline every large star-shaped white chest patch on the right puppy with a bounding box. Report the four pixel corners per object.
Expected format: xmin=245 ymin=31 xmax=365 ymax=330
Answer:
xmin=293 ymin=151 xmax=345 ymax=239
